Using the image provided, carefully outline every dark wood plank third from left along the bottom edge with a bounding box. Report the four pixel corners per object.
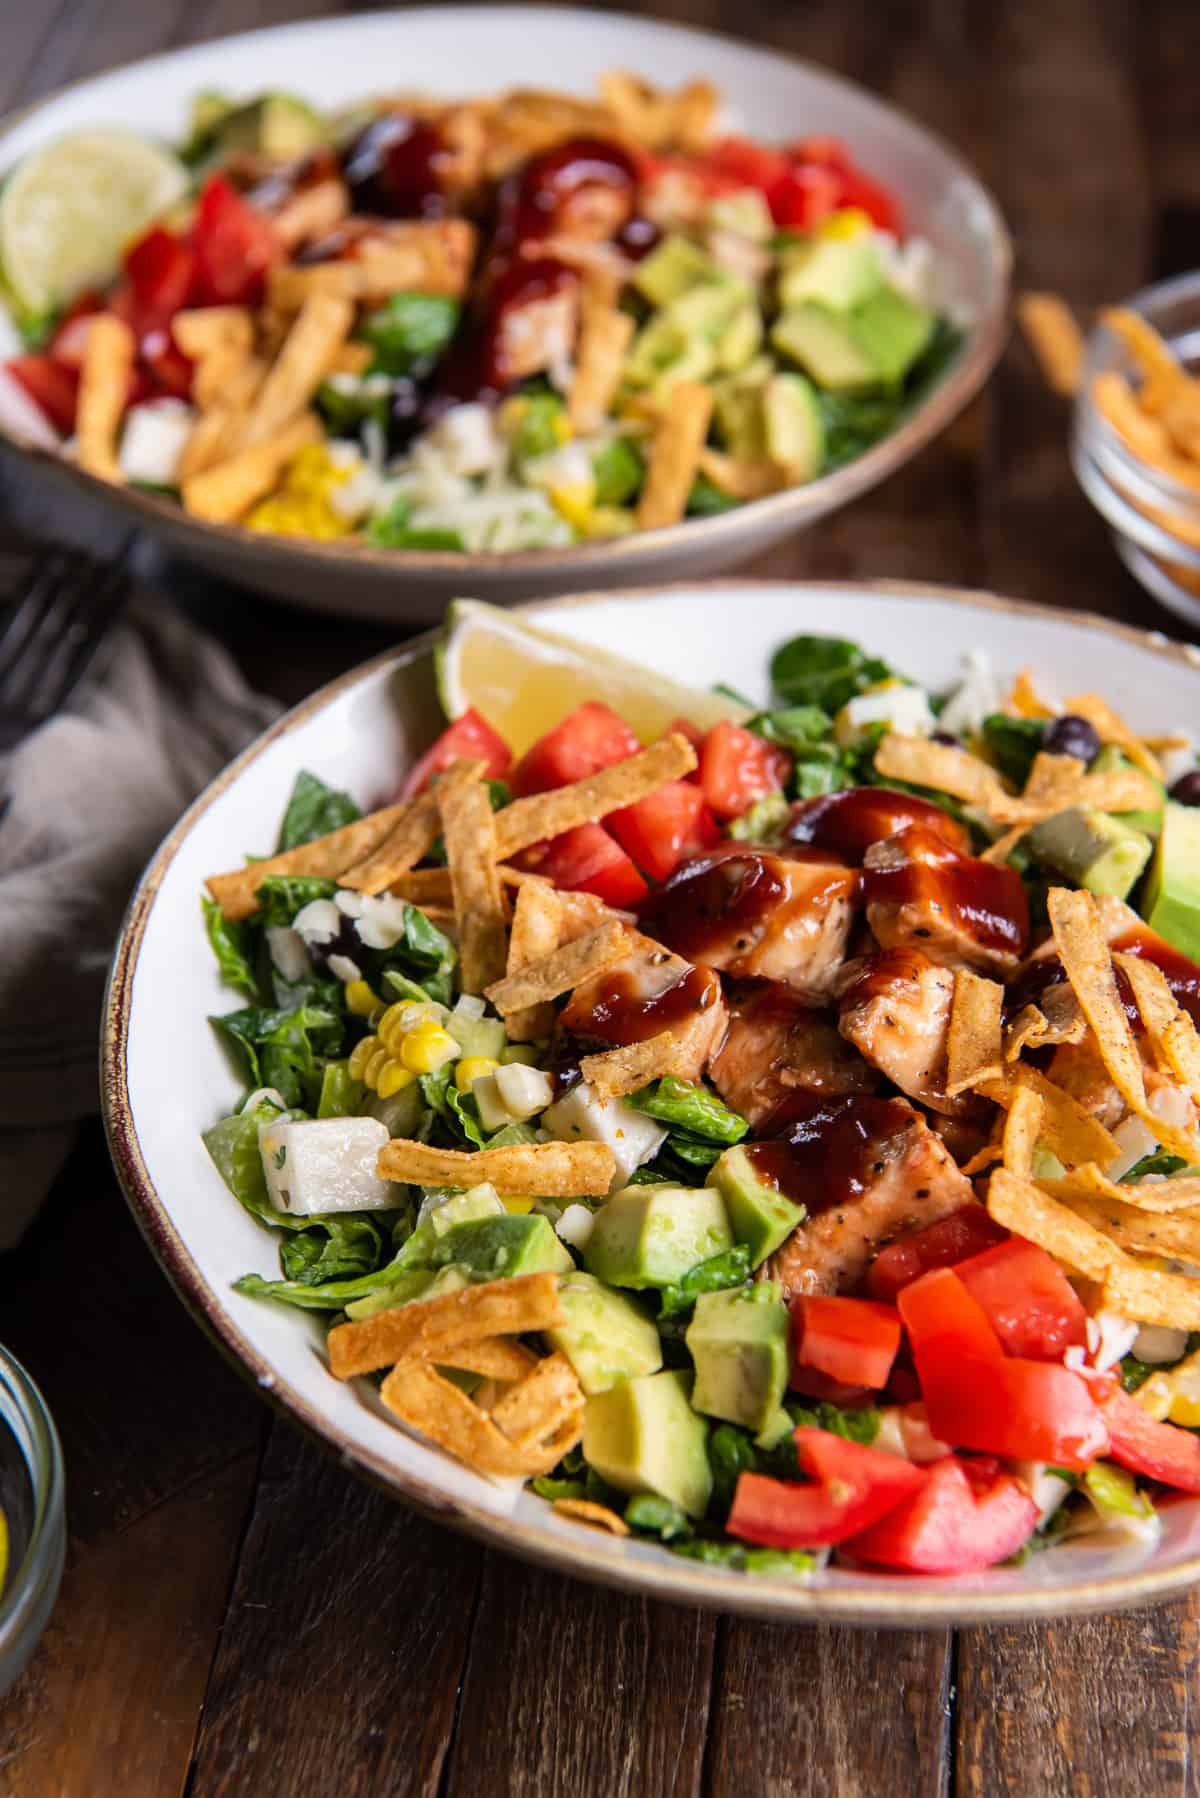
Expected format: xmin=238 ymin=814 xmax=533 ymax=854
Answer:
xmin=446 ymin=1555 xmax=716 ymax=1798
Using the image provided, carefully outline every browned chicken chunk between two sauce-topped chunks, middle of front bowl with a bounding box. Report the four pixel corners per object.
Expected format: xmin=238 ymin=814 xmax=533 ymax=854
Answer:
xmin=709 ymin=982 xmax=876 ymax=1131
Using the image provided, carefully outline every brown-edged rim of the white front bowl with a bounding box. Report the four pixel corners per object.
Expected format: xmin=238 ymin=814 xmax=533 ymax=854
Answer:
xmin=101 ymin=577 xmax=1200 ymax=1629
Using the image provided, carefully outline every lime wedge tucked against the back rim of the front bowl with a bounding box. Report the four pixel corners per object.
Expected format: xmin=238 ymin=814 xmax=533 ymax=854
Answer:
xmin=435 ymin=599 xmax=747 ymax=755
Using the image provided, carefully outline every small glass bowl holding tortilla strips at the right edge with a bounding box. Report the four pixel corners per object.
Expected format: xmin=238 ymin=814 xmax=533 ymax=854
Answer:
xmin=1070 ymin=273 xmax=1200 ymax=624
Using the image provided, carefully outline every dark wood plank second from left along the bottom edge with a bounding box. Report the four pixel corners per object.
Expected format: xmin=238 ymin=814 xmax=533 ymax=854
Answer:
xmin=193 ymin=1424 xmax=482 ymax=1798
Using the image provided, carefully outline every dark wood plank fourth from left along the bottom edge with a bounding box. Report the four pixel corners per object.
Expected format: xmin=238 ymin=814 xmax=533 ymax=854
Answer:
xmin=709 ymin=1620 xmax=949 ymax=1798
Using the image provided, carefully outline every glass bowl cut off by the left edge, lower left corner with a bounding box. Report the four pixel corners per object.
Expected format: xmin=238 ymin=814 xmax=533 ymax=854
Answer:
xmin=0 ymin=1349 xmax=67 ymax=1696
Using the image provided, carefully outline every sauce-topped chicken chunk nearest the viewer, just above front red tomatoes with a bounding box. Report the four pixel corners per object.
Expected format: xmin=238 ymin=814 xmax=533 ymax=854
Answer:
xmin=766 ymin=1097 xmax=975 ymax=1298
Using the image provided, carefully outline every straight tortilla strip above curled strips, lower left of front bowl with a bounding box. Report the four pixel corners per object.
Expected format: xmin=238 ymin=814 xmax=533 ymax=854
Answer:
xmin=326 ymin=1273 xmax=565 ymax=1379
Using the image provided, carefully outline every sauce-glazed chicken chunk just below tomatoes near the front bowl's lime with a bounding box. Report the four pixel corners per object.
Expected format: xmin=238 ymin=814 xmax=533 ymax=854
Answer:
xmin=644 ymin=847 xmax=858 ymax=1005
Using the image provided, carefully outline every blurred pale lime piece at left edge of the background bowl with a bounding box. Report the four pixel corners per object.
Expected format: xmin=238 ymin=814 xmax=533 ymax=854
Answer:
xmin=0 ymin=129 xmax=187 ymax=315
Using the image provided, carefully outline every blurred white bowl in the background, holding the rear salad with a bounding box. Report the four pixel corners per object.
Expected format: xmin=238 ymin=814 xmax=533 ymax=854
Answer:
xmin=0 ymin=5 xmax=1011 ymax=626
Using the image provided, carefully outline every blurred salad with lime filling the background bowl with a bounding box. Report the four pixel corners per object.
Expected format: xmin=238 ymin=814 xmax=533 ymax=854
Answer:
xmin=0 ymin=70 xmax=970 ymax=554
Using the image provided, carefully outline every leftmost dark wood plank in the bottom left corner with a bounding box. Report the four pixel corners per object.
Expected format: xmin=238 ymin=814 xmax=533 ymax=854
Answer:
xmin=0 ymin=1452 xmax=257 ymax=1798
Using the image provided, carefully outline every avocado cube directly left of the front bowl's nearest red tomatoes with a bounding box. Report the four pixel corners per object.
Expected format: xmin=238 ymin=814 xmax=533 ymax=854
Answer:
xmin=684 ymin=1280 xmax=788 ymax=1433
